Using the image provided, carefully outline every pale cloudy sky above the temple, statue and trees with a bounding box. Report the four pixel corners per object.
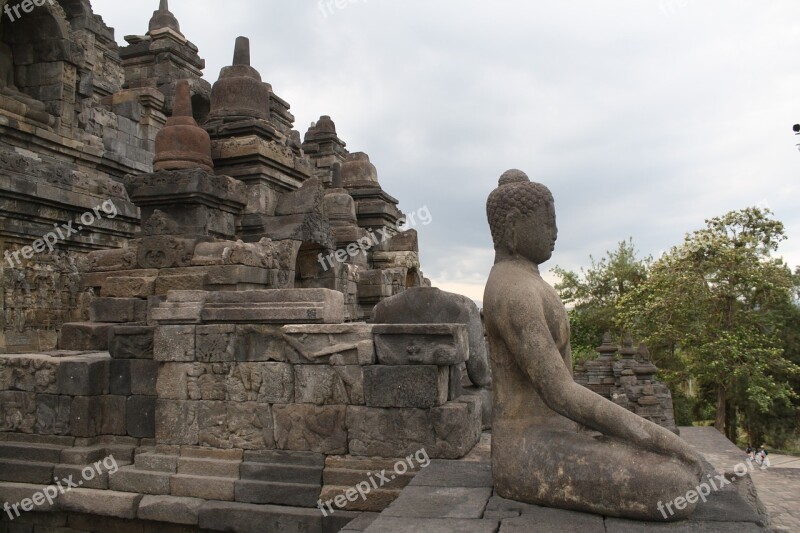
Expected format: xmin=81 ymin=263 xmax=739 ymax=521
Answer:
xmin=92 ymin=0 xmax=800 ymax=301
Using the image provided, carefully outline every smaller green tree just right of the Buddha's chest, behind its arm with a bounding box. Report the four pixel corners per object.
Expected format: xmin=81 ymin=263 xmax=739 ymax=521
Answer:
xmin=552 ymin=238 xmax=652 ymax=361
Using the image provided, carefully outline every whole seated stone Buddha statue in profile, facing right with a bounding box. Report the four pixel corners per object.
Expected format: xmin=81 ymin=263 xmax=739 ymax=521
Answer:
xmin=484 ymin=170 xmax=703 ymax=521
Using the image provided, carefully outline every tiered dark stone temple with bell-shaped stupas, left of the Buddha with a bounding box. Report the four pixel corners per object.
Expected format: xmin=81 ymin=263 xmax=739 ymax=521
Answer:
xmin=0 ymin=0 xmax=776 ymax=533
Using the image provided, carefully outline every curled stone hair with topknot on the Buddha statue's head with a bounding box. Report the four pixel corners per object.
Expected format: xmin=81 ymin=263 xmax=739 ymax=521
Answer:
xmin=486 ymin=169 xmax=554 ymax=248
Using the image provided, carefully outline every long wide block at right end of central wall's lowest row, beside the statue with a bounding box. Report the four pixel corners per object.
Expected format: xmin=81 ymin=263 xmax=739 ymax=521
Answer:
xmin=347 ymin=401 xmax=481 ymax=459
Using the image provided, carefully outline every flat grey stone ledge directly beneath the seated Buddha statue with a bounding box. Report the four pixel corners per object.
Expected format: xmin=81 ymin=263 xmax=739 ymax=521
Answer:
xmin=342 ymin=428 xmax=772 ymax=533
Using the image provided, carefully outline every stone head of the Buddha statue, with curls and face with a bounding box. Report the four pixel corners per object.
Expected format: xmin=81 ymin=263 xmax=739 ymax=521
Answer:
xmin=486 ymin=170 xmax=558 ymax=265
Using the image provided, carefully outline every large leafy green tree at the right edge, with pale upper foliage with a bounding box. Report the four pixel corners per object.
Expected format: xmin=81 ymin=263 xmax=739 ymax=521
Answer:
xmin=619 ymin=207 xmax=800 ymax=441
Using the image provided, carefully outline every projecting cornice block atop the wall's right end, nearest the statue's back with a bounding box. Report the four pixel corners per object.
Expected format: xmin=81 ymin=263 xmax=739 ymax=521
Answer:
xmin=372 ymin=324 xmax=469 ymax=366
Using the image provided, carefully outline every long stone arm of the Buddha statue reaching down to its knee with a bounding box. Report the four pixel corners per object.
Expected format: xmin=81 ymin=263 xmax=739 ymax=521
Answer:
xmin=498 ymin=291 xmax=701 ymax=471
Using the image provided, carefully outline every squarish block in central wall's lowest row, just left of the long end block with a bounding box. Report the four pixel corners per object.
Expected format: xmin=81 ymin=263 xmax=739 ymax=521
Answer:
xmin=272 ymin=404 xmax=347 ymax=454
